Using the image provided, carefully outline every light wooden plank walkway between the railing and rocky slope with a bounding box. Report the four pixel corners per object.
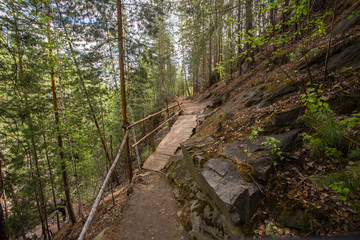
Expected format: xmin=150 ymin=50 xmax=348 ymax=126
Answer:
xmin=143 ymin=115 xmax=197 ymax=171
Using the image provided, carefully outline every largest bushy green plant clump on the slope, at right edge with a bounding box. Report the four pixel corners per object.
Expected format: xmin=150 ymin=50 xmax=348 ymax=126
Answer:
xmin=301 ymin=88 xmax=360 ymax=160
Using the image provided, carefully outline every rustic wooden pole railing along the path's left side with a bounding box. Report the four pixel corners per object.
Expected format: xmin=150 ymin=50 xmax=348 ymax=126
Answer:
xmin=78 ymin=102 xmax=183 ymax=240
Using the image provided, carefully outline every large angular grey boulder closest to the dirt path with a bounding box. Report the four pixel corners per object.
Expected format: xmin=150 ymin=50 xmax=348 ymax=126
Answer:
xmin=202 ymin=158 xmax=259 ymax=223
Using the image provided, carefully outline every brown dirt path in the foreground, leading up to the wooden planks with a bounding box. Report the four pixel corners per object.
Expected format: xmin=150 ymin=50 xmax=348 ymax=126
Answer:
xmin=106 ymin=171 xmax=189 ymax=240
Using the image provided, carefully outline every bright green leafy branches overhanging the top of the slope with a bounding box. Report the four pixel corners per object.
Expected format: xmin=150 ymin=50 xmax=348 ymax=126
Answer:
xmin=221 ymin=0 xmax=333 ymax=71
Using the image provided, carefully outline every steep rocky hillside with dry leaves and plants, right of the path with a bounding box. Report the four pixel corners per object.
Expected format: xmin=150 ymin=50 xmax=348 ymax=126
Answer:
xmin=167 ymin=3 xmax=360 ymax=239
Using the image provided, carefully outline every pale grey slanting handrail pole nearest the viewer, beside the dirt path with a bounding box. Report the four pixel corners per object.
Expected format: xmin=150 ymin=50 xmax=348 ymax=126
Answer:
xmin=78 ymin=131 xmax=130 ymax=240
